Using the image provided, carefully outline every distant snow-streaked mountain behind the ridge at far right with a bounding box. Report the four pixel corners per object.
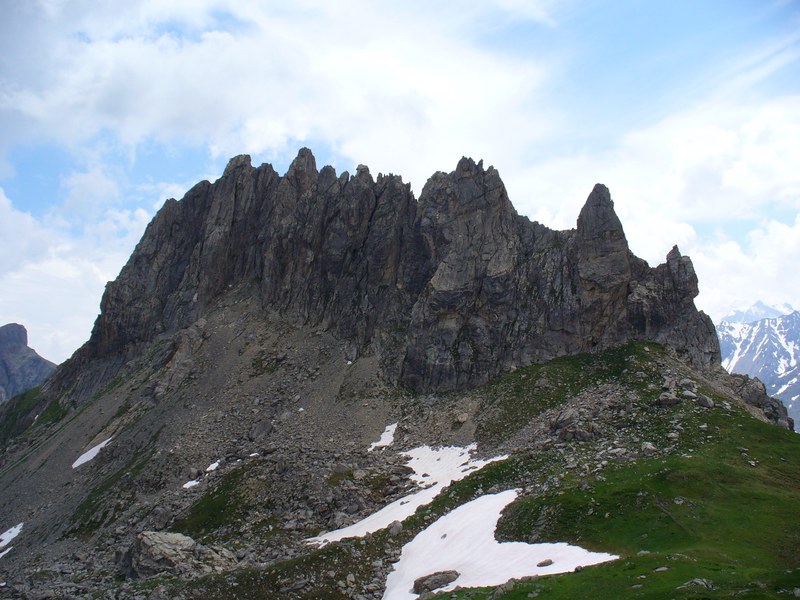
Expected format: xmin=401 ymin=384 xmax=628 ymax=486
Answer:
xmin=717 ymin=311 xmax=800 ymax=420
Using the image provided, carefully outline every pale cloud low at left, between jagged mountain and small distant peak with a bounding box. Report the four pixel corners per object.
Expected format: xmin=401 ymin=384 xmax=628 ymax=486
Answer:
xmin=0 ymin=190 xmax=150 ymax=362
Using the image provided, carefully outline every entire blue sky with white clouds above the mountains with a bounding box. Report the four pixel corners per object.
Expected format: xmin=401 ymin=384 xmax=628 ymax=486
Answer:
xmin=0 ymin=0 xmax=800 ymax=362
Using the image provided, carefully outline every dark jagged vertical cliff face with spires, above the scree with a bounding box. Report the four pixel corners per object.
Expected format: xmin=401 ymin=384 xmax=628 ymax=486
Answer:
xmin=56 ymin=149 xmax=720 ymax=391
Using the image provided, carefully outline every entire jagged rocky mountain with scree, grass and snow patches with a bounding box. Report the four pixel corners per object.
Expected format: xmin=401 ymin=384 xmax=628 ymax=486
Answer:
xmin=0 ymin=149 xmax=800 ymax=600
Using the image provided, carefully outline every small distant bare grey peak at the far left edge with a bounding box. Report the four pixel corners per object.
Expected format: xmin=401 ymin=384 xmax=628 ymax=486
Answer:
xmin=0 ymin=323 xmax=56 ymax=404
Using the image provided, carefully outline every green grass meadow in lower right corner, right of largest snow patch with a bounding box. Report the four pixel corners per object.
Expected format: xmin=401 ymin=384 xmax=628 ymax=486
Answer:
xmin=441 ymin=410 xmax=800 ymax=599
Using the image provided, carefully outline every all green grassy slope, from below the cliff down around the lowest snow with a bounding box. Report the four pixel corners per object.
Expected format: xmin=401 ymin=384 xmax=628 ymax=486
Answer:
xmin=153 ymin=344 xmax=800 ymax=599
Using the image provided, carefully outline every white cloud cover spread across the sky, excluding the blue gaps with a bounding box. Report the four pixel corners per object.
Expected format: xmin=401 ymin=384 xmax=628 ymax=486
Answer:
xmin=0 ymin=0 xmax=800 ymax=359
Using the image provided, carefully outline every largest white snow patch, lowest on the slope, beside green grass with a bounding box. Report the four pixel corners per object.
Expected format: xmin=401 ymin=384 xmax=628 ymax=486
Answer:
xmin=383 ymin=490 xmax=619 ymax=600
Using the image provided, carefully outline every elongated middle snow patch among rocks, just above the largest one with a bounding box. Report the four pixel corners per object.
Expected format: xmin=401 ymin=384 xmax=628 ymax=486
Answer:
xmin=306 ymin=444 xmax=508 ymax=546
